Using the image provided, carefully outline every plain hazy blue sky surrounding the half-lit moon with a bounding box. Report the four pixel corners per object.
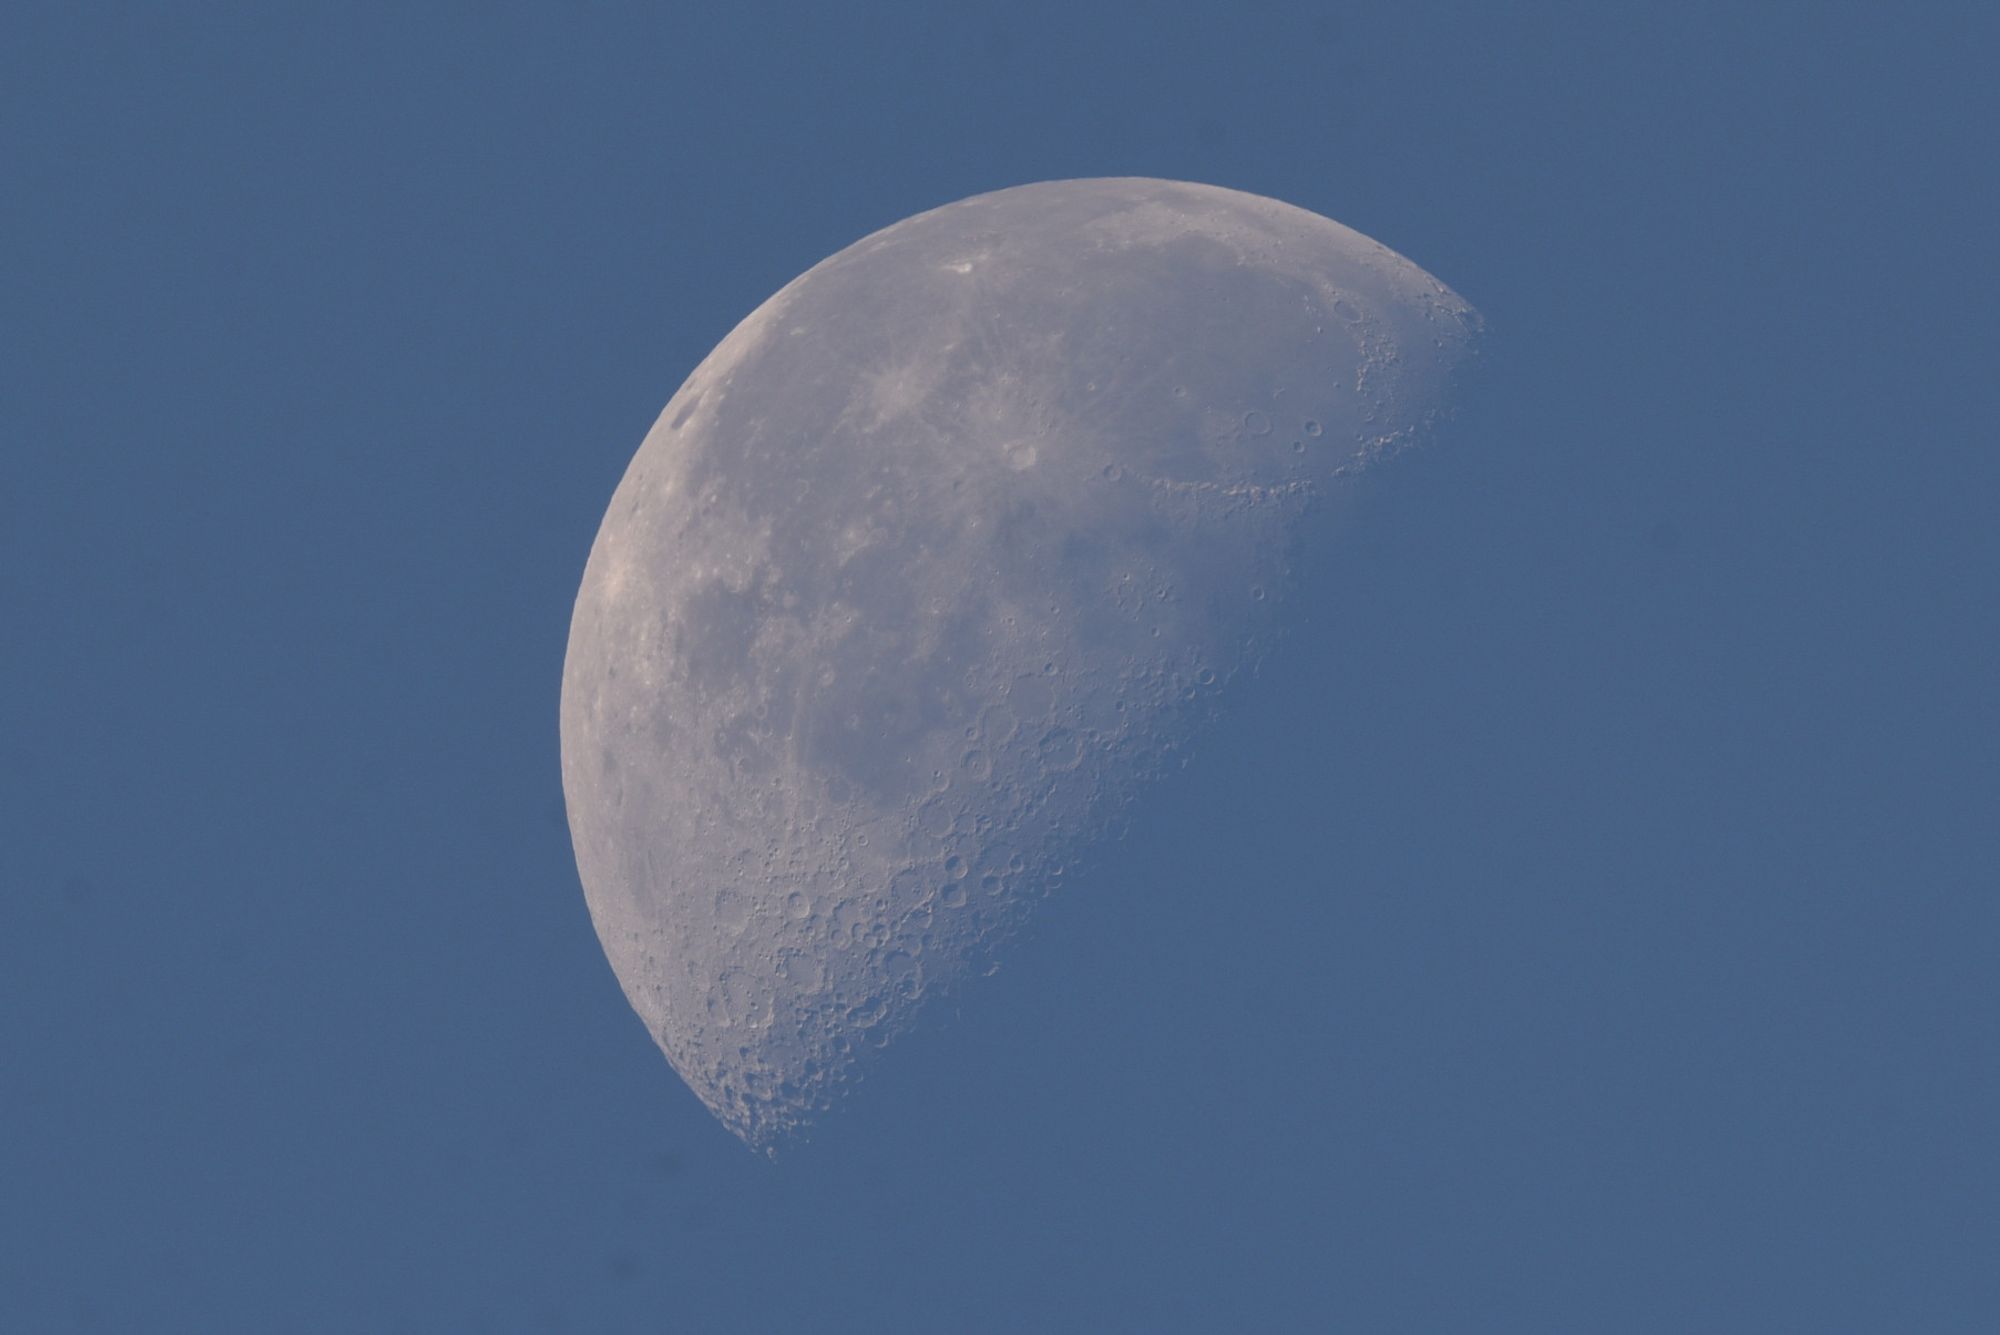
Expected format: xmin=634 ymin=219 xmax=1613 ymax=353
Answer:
xmin=0 ymin=0 xmax=2000 ymax=1335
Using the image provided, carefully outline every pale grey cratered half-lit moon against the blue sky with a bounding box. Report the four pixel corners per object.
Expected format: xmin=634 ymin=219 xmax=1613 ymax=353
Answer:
xmin=562 ymin=178 xmax=1478 ymax=1149
